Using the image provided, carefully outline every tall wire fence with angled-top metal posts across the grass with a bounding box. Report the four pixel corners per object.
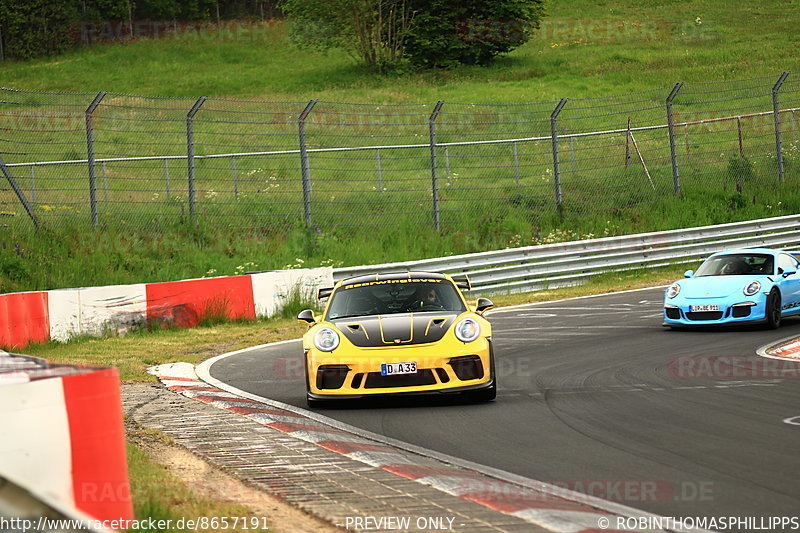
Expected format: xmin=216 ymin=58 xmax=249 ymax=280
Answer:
xmin=0 ymin=74 xmax=800 ymax=231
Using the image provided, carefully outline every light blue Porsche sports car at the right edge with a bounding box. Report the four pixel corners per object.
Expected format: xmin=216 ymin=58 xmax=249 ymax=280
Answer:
xmin=664 ymin=248 xmax=800 ymax=328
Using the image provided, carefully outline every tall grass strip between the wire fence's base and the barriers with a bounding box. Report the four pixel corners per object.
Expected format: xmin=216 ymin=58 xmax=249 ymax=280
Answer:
xmin=0 ymin=152 xmax=800 ymax=292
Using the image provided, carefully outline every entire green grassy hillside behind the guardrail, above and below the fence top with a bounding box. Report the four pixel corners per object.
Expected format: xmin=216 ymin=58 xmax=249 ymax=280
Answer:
xmin=0 ymin=0 xmax=800 ymax=292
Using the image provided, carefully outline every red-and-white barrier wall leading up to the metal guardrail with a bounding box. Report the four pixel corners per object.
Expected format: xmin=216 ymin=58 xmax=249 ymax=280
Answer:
xmin=0 ymin=267 xmax=333 ymax=348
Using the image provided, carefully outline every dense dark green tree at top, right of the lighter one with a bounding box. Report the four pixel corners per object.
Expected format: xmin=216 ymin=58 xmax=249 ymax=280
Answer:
xmin=405 ymin=0 xmax=544 ymax=68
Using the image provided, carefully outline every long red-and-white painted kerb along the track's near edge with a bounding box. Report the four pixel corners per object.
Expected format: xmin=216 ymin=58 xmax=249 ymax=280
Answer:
xmin=148 ymin=363 xmax=699 ymax=533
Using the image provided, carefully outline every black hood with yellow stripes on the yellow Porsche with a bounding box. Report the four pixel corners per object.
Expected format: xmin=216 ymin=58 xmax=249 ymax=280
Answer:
xmin=330 ymin=312 xmax=458 ymax=348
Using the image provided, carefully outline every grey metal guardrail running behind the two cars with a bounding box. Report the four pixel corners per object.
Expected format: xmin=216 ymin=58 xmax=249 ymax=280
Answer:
xmin=333 ymin=214 xmax=800 ymax=294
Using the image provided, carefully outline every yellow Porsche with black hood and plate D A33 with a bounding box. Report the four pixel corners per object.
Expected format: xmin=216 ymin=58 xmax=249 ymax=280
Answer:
xmin=297 ymin=272 xmax=497 ymax=406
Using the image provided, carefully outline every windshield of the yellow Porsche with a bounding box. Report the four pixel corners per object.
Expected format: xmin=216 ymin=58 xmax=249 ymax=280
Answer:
xmin=326 ymin=279 xmax=466 ymax=320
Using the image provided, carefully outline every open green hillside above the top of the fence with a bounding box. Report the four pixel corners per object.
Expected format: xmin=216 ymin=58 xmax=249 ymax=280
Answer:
xmin=0 ymin=0 xmax=800 ymax=103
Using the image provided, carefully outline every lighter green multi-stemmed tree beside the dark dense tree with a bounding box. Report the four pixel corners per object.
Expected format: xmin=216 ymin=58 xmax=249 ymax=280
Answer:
xmin=281 ymin=0 xmax=414 ymax=71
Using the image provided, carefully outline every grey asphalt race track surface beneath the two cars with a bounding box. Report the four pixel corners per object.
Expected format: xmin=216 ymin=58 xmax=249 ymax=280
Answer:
xmin=210 ymin=289 xmax=800 ymax=517
